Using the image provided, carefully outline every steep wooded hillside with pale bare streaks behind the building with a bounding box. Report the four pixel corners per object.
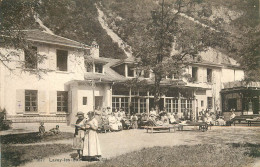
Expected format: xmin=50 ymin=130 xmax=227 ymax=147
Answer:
xmin=1 ymin=0 xmax=260 ymax=80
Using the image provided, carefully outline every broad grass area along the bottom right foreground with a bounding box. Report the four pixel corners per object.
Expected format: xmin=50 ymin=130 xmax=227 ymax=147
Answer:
xmin=91 ymin=144 xmax=260 ymax=167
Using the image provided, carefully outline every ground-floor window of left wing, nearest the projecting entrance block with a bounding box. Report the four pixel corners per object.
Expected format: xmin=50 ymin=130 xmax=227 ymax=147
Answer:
xmin=57 ymin=91 xmax=68 ymax=112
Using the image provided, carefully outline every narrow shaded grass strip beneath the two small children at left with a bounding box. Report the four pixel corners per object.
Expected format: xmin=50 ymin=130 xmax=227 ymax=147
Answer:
xmin=1 ymin=132 xmax=74 ymax=144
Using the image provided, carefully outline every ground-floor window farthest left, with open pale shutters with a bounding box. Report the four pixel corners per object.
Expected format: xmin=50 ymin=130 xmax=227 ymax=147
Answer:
xmin=25 ymin=90 xmax=38 ymax=112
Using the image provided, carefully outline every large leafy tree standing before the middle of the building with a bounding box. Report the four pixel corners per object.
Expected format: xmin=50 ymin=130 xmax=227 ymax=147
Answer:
xmin=131 ymin=0 xmax=222 ymax=110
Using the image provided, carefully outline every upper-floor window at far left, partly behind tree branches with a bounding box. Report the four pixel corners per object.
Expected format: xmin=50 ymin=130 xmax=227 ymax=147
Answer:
xmin=24 ymin=46 xmax=37 ymax=69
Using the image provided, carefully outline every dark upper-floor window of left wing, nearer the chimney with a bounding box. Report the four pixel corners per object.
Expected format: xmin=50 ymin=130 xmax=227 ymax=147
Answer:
xmin=56 ymin=50 xmax=68 ymax=71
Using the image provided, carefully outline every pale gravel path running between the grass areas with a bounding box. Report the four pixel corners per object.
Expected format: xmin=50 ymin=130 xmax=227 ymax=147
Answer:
xmin=19 ymin=126 xmax=260 ymax=167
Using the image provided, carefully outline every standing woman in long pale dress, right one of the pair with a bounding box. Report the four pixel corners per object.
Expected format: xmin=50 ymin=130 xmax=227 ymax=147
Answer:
xmin=82 ymin=111 xmax=101 ymax=161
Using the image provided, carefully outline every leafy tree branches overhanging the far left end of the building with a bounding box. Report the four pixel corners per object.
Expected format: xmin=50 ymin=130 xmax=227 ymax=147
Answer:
xmin=0 ymin=0 xmax=47 ymax=77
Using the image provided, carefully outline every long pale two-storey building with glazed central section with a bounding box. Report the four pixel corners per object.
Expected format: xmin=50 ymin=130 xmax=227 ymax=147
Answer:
xmin=0 ymin=30 xmax=244 ymax=123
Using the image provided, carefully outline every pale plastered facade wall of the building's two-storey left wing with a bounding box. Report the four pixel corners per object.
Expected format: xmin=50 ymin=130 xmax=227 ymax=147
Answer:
xmin=0 ymin=44 xmax=85 ymax=115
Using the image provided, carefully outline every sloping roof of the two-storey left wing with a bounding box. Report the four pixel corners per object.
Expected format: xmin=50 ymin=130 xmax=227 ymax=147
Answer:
xmin=22 ymin=29 xmax=90 ymax=49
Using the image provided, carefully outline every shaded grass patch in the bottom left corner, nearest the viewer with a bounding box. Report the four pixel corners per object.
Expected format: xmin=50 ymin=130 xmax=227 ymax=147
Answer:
xmin=1 ymin=144 xmax=73 ymax=166
